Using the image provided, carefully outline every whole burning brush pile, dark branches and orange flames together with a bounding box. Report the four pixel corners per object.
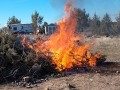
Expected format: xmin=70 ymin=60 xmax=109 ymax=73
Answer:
xmin=0 ymin=3 xmax=105 ymax=83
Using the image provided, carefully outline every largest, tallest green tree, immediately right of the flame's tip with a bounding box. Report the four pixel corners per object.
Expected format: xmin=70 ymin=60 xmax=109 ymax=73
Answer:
xmin=75 ymin=8 xmax=89 ymax=32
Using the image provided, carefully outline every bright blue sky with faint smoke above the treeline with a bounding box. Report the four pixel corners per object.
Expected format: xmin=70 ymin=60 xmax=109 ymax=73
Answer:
xmin=0 ymin=0 xmax=120 ymax=27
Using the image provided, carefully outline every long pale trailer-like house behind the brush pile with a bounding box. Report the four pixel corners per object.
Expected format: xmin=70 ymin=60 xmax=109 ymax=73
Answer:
xmin=8 ymin=24 xmax=34 ymax=34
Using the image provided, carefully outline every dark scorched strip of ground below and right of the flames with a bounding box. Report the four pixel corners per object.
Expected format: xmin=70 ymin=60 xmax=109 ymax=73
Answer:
xmin=62 ymin=62 xmax=120 ymax=76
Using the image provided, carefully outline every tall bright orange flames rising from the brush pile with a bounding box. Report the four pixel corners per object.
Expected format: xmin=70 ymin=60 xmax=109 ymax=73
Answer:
xmin=22 ymin=3 xmax=100 ymax=71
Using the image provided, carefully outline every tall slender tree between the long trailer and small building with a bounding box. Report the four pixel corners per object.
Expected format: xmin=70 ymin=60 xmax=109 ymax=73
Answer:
xmin=31 ymin=11 xmax=43 ymax=34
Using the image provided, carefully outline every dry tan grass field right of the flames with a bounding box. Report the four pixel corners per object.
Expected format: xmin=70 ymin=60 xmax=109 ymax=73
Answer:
xmin=88 ymin=37 xmax=120 ymax=62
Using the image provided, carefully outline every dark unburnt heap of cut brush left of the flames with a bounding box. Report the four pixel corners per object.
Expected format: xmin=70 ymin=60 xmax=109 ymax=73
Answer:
xmin=0 ymin=28 xmax=56 ymax=82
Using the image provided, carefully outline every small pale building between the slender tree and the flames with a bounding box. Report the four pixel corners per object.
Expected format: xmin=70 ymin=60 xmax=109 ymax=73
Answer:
xmin=45 ymin=24 xmax=57 ymax=35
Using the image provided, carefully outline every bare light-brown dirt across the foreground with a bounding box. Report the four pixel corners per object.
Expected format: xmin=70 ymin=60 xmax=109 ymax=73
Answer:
xmin=0 ymin=73 xmax=120 ymax=90
